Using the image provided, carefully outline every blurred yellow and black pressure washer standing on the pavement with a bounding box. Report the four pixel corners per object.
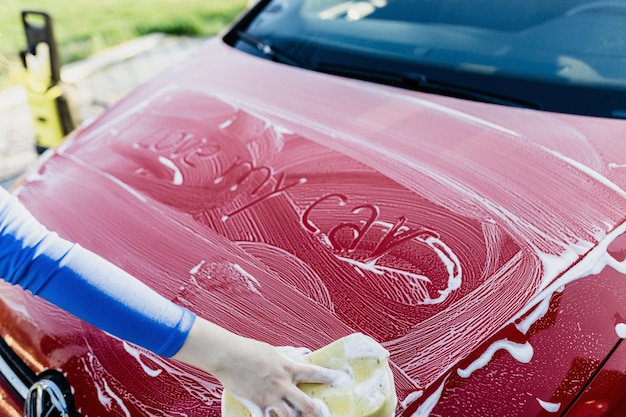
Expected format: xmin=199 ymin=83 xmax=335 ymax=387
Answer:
xmin=20 ymin=11 xmax=77 ymax=154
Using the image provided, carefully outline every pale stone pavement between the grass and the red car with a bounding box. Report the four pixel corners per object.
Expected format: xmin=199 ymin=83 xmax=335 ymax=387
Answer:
xmin=0 ymin=34 xmax=206 ymax=188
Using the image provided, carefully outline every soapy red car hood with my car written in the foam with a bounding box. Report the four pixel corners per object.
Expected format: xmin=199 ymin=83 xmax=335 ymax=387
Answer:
xmin=8 ymin=40 xmax=626 ymax=412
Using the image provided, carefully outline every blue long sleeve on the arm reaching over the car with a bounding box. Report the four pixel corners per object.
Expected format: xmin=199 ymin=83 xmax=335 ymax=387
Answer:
xmin=0 ymin=188 xmax=195 ymax=357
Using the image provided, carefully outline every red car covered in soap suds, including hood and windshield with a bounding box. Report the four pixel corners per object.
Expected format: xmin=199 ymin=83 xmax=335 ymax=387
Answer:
xmin=0 ymin=0 xmax=626 ymax=417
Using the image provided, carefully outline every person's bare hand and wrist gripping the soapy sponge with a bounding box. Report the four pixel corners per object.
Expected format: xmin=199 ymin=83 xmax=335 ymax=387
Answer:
xmin=173 ymin=317 xmax=345 ymax=417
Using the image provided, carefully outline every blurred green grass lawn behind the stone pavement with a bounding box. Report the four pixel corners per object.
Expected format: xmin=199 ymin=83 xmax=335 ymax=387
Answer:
xmin=0 ymin=0 xmax=246 ymax=87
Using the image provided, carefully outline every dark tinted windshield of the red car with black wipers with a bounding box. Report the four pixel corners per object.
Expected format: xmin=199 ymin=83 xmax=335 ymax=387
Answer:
xmin=225 ymin=0 xmax=626 ymax=118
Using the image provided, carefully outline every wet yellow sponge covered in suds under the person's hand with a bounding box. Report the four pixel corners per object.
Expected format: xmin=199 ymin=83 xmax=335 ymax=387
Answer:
xmin=222 ymin=333 xmax=397 ymax=417
